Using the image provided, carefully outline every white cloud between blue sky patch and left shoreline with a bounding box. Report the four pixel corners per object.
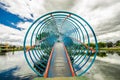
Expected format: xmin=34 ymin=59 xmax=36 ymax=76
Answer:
xmin=0 ymin=24 xmax=25 ymax=45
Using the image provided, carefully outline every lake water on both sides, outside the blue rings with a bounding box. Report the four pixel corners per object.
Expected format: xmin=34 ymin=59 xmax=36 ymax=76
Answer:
xmin=0 ymin=51 xmax=120 ymax=80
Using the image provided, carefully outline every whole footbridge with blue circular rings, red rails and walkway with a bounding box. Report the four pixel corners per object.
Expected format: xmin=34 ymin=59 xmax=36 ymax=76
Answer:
xmin=24 ymin=11 xmax=98 ymax=78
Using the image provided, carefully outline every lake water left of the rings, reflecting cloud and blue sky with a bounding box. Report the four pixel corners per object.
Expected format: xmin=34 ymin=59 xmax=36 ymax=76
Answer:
xmin=0 ymin=51 xmax=35 ymax=77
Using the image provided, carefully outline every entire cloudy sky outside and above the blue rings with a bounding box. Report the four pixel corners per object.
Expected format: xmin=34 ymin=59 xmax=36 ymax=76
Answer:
xmin=0 ymin=0 xmax=120 ymax=45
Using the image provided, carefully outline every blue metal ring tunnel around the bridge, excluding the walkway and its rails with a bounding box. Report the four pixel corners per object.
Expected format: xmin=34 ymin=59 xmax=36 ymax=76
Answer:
xmin=24 ymin=11 xmax=98 ymax=76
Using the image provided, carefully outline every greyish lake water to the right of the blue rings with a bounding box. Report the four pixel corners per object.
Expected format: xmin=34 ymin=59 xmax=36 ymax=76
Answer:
xmin=85 ymin=51 xmax=120 ymax=80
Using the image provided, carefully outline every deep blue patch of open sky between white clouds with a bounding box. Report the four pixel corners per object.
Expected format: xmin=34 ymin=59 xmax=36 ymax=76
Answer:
xmin=0 ymin=5 xmax=33 ymax=30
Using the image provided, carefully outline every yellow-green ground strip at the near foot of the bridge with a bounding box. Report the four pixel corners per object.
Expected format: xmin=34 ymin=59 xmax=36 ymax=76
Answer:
xmin=33 ymin=76 xmax=89 ymax=80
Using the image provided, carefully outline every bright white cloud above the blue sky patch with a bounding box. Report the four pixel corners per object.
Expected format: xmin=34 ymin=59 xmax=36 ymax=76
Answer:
xmin=1 ymin=0 xmax=44 ymax=19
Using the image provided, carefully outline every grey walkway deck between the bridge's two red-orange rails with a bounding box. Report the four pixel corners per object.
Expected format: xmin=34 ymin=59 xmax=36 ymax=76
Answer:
xmin=48 ymin=42 xmax=72 ymax=77
